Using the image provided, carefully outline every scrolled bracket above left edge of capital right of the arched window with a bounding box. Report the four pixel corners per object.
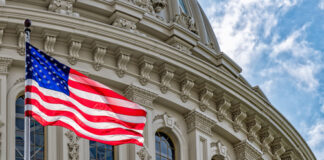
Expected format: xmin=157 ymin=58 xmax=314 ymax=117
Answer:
xmin=180 ymin=73 xmax=195 ymax=103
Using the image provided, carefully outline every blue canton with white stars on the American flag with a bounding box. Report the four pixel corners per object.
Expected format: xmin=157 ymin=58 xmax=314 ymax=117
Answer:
xmin=26 ymin=43 xmax=70 ymax=95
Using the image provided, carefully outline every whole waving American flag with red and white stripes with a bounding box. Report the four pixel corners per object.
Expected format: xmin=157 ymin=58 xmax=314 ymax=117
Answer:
xmin=25 ymin=43 xmax=146 ymax=146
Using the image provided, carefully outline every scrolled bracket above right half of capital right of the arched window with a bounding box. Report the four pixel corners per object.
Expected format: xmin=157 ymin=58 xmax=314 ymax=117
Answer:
xmin=199 ymin=83 xmax=214 ymax=112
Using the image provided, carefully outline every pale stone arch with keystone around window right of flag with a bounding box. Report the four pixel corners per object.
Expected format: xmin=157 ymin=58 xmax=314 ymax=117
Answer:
xmin=152 ymin=113 xmax=188 ymax=160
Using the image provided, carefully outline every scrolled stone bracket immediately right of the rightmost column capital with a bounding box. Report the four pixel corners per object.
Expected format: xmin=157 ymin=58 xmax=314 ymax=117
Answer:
xmin=259 ymin=126 xmax=274 ymax=153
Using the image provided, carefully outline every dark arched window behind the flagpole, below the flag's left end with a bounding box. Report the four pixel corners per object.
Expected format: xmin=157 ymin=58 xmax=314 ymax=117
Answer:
xmin=15 ymin=96 xmax=45 ymax=160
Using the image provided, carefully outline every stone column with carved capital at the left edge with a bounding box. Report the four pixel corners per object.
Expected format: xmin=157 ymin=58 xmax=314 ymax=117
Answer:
xmin=0 ymin=57 xmax=12 ymax=159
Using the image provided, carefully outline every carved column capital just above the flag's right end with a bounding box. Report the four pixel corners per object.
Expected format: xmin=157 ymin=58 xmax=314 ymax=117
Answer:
xmin=124 ymin=85 xmax=158 ymax=109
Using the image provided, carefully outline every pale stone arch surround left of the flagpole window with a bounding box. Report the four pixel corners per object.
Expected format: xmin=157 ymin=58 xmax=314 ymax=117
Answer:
xmin=7 ymin=80 xmax=25 ymax=159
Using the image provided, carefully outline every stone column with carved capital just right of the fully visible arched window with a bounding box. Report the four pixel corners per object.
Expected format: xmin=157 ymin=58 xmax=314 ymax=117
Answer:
xmin=185 ymin=110 xmax=216 ymax=160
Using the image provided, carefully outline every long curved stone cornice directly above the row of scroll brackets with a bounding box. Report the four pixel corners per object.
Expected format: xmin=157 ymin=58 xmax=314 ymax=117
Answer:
xmin=0 ymin=6 xmax=314 ymax=159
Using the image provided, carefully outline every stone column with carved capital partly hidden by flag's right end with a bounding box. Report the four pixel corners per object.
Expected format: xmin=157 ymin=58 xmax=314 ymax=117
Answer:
xmin=123 ymin=85 xmax=158 ymax=160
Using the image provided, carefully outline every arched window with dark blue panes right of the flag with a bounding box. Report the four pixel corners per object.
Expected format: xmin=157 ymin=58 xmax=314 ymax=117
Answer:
xmin=155 ymin=132 xmax=175 ymax=160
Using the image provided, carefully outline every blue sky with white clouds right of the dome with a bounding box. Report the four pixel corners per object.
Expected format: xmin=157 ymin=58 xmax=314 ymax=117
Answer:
xmin=198 ymin=0 xmax=324 ymax=160
